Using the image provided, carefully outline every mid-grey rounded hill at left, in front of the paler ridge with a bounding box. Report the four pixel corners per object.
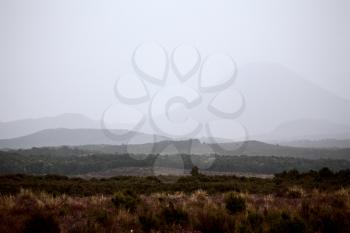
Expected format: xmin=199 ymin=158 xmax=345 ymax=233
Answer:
xmin=0 ymin=128 xmax=167 ymax=149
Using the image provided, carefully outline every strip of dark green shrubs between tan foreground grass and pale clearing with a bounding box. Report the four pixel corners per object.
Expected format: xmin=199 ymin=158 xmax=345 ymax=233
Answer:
xmin=0 ymin=168 xmax=350 ymax=197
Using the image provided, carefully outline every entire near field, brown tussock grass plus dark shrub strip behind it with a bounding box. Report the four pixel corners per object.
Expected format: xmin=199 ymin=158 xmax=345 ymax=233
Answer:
xmin=0 ymin=168 xmax=350 ymax=233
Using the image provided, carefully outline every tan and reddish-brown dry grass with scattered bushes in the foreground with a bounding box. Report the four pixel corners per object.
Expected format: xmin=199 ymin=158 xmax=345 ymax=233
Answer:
xmin=0 ymin=187 xmax=350 ymax=233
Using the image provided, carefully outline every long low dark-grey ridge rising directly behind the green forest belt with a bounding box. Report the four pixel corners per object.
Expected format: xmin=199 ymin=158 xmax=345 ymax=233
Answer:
xmin=2 ymin=136 xmax=350 ymax=160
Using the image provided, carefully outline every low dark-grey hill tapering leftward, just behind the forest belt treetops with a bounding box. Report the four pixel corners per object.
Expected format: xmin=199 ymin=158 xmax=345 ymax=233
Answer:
xmin=78 ymin=140 xmax=350 ymax=160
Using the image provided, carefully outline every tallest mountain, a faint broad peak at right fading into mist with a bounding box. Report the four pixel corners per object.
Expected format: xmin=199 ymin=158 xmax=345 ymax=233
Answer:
xmin=138 ymin=63 xmax=350 ymax=142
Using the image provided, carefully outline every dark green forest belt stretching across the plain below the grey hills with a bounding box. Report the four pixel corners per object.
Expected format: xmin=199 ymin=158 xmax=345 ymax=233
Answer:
xmin=0 ymin=150 xmax=350 ymax=176
